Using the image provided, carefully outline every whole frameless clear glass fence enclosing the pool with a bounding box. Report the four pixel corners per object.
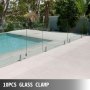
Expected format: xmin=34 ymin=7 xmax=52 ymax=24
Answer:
xmin=0 ymin=19 xmax=85 ymax=67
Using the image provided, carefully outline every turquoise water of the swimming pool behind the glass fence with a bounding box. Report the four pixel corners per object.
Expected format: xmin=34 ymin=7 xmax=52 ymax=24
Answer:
xmin=0 ymin=33 xmax=49 ymax=54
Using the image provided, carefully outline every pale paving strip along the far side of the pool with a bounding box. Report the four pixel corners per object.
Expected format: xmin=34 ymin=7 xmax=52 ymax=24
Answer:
xmin=9 ymin=29 xmax=81 ymax=41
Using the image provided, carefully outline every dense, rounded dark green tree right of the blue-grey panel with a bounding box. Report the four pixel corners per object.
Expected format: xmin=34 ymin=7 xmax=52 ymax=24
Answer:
xmin=56 ymin=0 xmax=80 ymax=31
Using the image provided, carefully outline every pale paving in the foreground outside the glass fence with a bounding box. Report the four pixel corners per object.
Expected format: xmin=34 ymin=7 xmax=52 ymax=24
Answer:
xmin=0 ymin=36 xmax=90 ymax=79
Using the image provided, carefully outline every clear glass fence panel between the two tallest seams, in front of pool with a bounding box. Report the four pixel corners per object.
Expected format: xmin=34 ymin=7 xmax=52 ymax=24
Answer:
xmin=26 ymin=20 xmax=43 ymax=56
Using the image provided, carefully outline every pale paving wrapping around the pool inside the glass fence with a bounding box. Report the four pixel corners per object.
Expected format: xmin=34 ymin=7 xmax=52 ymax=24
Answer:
xmin=0 ymin=29 xmax=81 ymax=67
